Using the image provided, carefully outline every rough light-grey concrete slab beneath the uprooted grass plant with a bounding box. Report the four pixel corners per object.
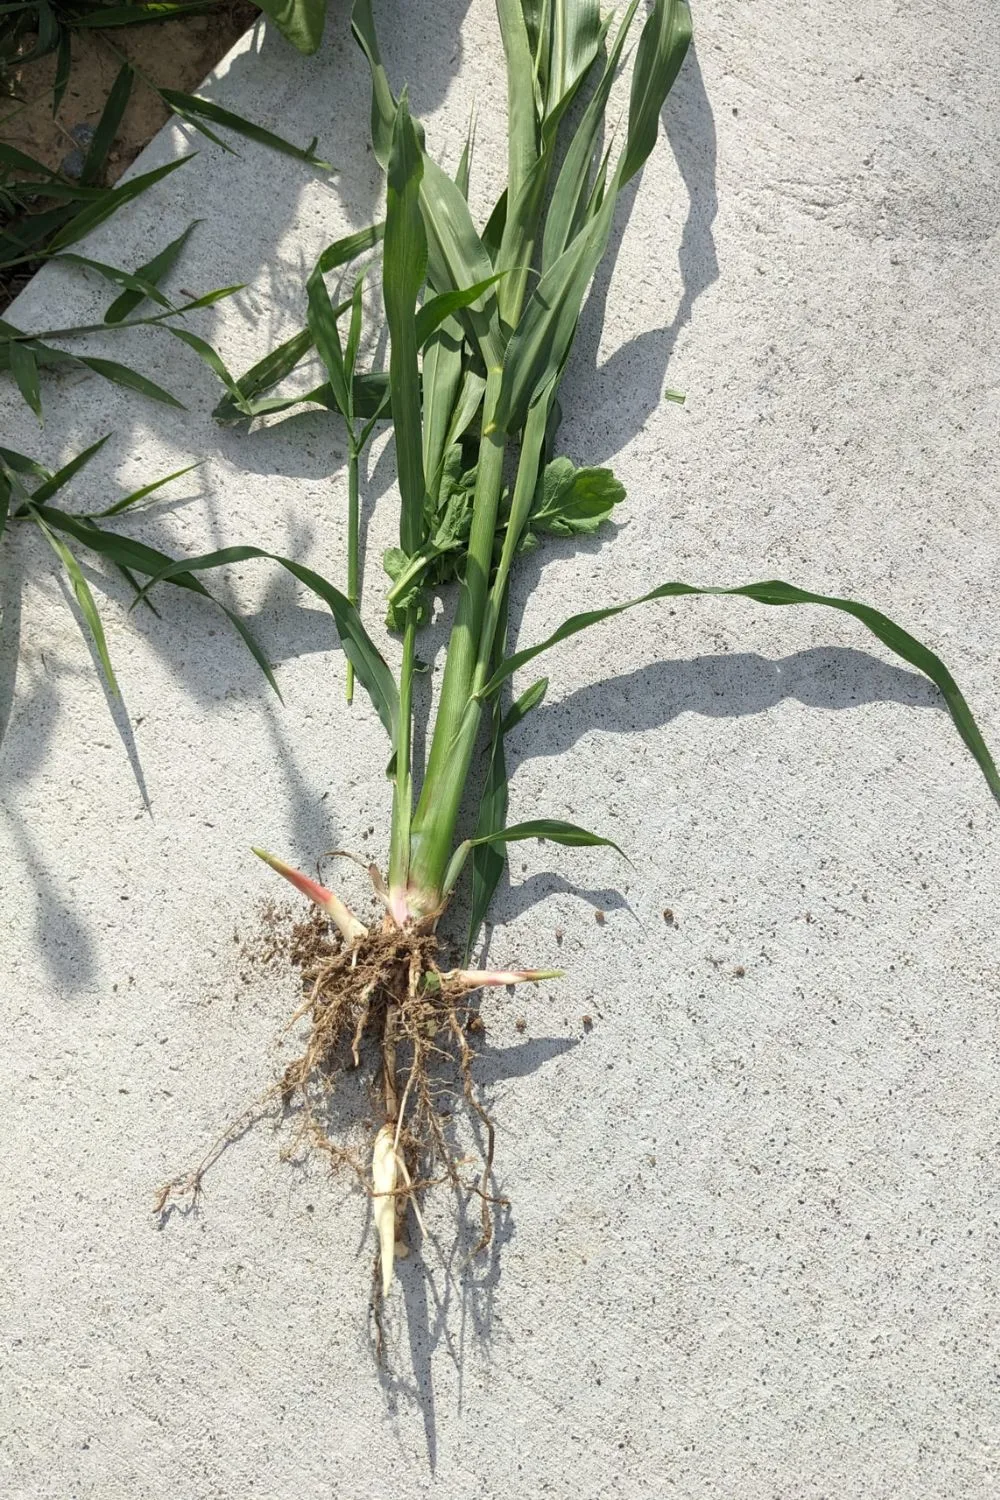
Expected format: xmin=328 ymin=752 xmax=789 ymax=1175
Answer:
xmin=0 ymin=0 xmax=1000 ymax=1500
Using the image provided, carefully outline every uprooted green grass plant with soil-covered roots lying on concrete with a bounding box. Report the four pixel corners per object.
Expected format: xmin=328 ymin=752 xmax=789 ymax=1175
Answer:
xmin=153 ymin=0 xmax=1000 ymax=1320
